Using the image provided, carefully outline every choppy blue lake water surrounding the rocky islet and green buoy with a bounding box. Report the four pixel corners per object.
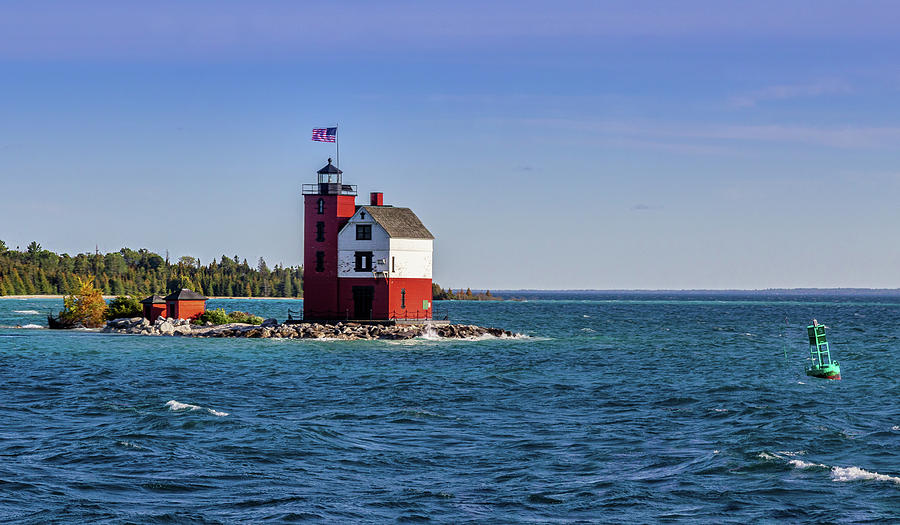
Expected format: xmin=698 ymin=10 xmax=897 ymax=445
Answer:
xmin=0 ymin=293 xmax=900 ymax=523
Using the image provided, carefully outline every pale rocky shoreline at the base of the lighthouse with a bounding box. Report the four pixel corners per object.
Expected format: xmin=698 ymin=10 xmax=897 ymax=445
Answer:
xmin=102 ymin=317 xmax=519 ymax=340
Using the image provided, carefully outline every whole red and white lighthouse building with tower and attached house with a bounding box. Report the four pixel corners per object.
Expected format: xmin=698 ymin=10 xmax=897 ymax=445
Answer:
xmin=303 ymin=159 xmax=434 ymax=322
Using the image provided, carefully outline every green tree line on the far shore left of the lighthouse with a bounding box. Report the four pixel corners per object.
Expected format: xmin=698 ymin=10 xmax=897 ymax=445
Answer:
xmin=0 ymin=240 xmax=303 ymax=297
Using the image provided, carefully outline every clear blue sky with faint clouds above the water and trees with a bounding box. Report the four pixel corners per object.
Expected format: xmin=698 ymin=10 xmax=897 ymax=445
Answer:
xmin=0 ymin=1 xmax=900 ymax=289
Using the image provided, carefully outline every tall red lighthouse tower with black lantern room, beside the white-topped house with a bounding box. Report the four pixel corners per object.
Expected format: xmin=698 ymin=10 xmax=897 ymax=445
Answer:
xmin=303 ymin=159 xmax=356 ymax=319
